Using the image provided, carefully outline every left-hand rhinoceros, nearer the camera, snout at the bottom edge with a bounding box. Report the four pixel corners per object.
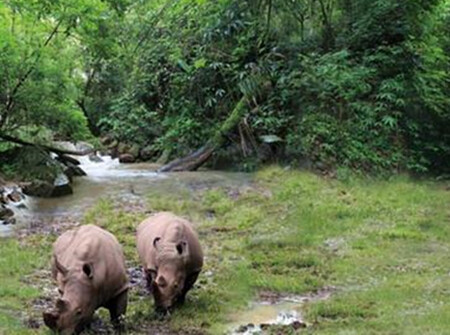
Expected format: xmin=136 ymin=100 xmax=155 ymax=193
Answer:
xmin=43 ymin=225 xmax=128 ymax=334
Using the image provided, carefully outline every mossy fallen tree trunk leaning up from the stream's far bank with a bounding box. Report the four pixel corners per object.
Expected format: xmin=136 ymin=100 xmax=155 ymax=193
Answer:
xmin=158 ymin=97 xmax=247 ymax=172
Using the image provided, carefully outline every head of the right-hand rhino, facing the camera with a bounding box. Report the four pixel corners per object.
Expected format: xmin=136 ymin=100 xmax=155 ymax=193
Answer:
xmin=148 ymin=238 xmax=189 ymax=311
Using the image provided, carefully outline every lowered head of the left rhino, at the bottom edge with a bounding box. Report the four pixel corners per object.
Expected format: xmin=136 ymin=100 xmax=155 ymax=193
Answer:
xmin=43 ymin=258 xmax=95 ymax=335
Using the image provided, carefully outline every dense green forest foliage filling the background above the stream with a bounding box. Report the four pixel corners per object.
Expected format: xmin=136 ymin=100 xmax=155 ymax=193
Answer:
xmin=0 ymin=0 xmax=450 ymax=173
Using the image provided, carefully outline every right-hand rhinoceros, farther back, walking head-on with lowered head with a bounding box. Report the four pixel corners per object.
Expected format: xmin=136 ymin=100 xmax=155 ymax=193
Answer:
xmin=136 ymin=212 xmax=203 ymax=311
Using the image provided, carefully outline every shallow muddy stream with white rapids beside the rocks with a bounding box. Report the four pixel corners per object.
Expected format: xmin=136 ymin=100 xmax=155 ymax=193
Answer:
xmin=4 ymin=156 xmax=249 ymax=234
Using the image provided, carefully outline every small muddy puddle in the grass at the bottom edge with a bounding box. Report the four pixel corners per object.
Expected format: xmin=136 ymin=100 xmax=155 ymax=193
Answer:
xmin=228 ymin=288 xmax=332 ymax=335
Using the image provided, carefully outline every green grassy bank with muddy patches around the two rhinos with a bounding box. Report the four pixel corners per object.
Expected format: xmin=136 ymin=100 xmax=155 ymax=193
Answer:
xmin=0 ymin=167 xmax=450 ymax=334
